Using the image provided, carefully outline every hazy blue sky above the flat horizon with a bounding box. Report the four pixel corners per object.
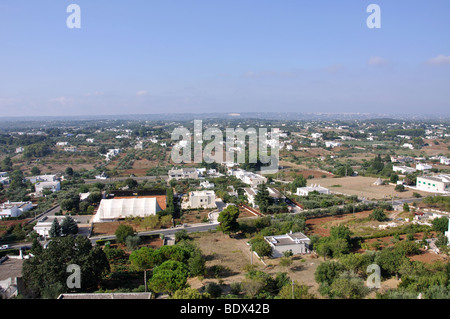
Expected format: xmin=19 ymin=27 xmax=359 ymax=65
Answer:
xmin=0 ymin=0 xmax=450 ymax=116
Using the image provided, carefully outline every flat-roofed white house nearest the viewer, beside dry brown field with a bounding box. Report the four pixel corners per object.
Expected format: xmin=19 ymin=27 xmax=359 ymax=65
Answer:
xmin=264 ymin=232 xmax=311 ymax=258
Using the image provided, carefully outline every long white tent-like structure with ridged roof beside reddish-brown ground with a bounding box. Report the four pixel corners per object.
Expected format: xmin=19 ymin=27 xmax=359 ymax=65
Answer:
xmin=92 ymin=197 xmax=162 ymax=223
